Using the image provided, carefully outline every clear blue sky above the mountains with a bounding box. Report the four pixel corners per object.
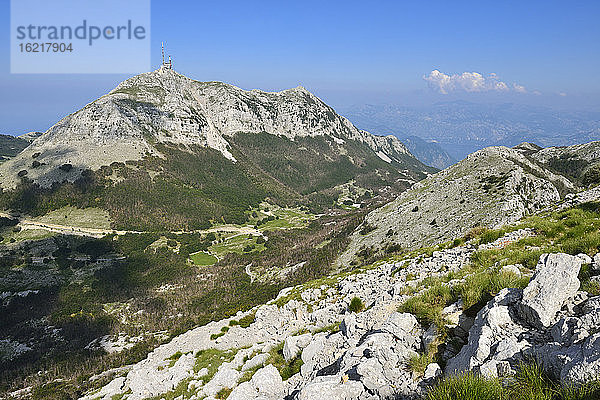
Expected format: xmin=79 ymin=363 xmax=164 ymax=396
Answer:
xmin=0 ymin=0 xmax=600 ymax=134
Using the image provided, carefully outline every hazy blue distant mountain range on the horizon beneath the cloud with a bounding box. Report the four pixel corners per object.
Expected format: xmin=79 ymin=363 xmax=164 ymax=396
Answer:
xmin=341 ymin=101 xmax=600 ymax=160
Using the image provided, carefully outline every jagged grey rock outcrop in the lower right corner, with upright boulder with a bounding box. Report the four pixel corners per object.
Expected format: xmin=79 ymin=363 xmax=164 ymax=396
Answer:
xmin=446 ymin=250 xmax=600 ymax=382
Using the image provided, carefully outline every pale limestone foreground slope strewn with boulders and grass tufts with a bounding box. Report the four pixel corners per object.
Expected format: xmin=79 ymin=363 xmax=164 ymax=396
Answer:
xmin=84 ymin=225 xmax=600 ymax=400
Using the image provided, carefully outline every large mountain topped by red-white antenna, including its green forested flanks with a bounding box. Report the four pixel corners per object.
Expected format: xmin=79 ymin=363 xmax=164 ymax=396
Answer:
xmin=0 ymin=68 xmax=436 ymax=230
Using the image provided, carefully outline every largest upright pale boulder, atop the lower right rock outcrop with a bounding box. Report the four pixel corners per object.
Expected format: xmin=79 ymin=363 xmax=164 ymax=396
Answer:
xmin=519 ymin=253 xmax=582 ymax=328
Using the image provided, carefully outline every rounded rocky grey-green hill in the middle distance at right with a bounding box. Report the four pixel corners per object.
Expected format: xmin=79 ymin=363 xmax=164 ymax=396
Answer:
xmin=338 ymin=147 xmax=576 ymax=265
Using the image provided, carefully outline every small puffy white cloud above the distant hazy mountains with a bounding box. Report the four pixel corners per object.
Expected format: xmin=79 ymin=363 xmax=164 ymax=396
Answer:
xmin=423 ymin=69 xmax=527 ymax=94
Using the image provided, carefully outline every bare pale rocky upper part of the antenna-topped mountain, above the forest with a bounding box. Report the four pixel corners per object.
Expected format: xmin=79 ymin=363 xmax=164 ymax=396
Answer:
xmin=0 ymin=68 xmax=432 ymax=188
